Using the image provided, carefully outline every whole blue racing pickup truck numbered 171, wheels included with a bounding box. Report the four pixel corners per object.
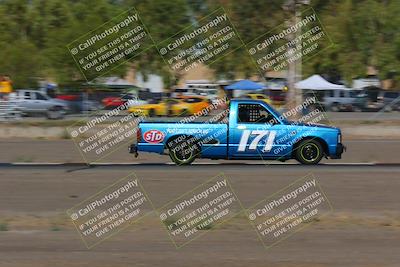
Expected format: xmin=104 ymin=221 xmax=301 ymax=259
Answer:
xmin=129 ymin=99 xmax=345 ymax=165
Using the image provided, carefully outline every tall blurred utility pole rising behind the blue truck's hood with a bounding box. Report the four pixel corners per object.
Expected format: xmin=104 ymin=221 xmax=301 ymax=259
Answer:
xmin=283 ymin=0 xmax=310 ymax=120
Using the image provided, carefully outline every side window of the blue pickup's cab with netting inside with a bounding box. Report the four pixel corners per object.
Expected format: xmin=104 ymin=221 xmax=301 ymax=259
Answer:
xmin=238 ymin=104 xmax=277 ymax=124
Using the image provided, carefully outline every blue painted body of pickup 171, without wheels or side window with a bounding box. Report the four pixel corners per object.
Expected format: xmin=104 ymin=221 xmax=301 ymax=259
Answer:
xmin=130 ymin=99 xmax=345 ymax=160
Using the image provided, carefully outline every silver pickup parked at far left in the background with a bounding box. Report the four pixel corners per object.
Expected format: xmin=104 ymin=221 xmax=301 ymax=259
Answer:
xmin=11 ymin=90 xmax=68 ymax=119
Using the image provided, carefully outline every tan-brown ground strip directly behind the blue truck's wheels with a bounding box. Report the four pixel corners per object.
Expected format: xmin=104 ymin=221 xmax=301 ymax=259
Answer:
xmin=0 ymin=138 xmax=400 ymax=164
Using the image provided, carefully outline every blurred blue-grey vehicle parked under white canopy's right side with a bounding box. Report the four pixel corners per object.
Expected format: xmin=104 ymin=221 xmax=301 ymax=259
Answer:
xmin=322 ymin=89 xmax=367 ymax=112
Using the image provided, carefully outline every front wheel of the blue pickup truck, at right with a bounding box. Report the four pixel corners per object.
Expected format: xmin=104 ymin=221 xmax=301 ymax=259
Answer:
xmin=295 ymin=139 xmax=324 ymax=165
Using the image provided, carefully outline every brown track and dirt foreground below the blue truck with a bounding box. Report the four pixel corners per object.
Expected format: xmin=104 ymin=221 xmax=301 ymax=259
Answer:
xmin=0 ymin=162 xmax=400 ymax=267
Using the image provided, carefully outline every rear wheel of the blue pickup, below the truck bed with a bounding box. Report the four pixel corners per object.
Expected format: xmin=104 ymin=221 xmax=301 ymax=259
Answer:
xmin=167 ymin=136 xmax=200 ymax=165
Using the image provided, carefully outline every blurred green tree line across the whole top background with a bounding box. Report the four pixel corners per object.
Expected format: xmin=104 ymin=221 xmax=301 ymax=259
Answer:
xmin=0 ymin=0 xmax=400 ymax=87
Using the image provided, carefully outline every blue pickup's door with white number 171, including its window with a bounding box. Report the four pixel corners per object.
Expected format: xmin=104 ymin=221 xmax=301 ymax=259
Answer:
xmin=229 ymin=102 xmax=286 ymax=158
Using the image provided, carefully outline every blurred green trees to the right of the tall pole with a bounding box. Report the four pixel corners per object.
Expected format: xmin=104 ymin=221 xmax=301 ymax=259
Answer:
xmin=304 ymin=0 xmax=400 ymax=86
